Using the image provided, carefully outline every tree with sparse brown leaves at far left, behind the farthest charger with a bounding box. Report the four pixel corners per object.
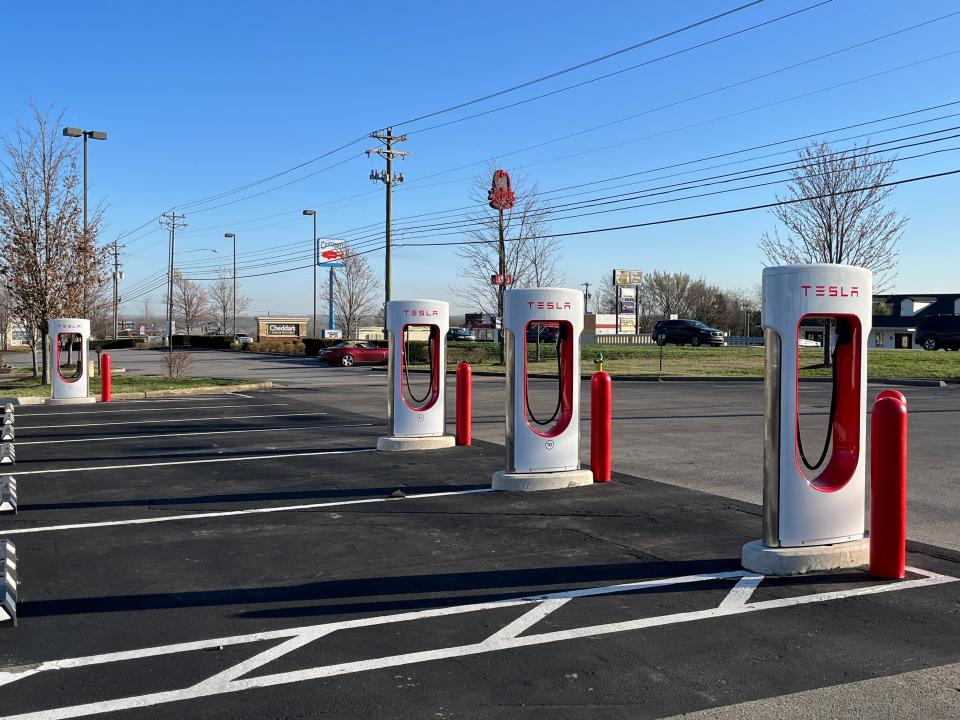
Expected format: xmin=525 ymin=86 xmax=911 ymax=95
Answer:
xmin=0 ymin=106 xmax=106 ymax=383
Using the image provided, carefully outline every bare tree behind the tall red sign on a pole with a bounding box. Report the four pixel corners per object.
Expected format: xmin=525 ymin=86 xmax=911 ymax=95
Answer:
xmin=456 ymin=164 xmax=564 ymax=324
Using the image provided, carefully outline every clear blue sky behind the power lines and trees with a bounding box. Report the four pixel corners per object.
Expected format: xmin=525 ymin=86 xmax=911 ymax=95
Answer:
xmin=0 ymin=0 xmax=960 ymax=316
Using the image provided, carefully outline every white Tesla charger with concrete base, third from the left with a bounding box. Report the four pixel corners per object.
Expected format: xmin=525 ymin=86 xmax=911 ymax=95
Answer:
xmin=493 ymin=288 xmax=593 ymax=490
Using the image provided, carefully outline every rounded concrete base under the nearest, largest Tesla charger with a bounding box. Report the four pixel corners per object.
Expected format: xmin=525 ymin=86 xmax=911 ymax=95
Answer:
xmin=740 ymin=538 xmax=870 ymax=575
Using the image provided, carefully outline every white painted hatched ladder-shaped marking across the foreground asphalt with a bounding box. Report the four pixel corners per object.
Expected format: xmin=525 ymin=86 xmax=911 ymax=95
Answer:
xmin=0 ymin=568 xmax=957 ymax=720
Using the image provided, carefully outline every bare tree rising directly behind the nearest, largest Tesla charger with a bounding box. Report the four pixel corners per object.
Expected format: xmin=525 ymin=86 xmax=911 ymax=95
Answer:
xmin=760 ymin=141 xmax=907 ymax=365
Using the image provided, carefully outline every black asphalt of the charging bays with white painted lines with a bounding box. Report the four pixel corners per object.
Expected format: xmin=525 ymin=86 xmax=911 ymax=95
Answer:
xmin=0 ymin=390 xmax=960 ymax=719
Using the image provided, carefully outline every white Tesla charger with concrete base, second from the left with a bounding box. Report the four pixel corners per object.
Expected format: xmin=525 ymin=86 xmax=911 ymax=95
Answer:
xmin=377 ymin=300 xmax=455 ymax=451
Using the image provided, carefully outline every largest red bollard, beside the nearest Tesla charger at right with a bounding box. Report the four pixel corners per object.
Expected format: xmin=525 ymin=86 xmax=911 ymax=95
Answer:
xmin=870 ymin=390 xmax=907 ymax=578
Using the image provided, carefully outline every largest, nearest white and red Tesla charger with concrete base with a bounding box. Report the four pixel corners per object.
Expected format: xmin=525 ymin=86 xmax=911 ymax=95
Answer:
xmin=742 ymin=264 xmax=873 ymax=574
